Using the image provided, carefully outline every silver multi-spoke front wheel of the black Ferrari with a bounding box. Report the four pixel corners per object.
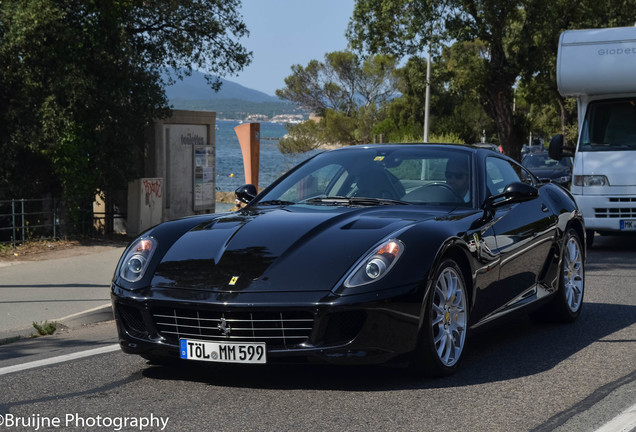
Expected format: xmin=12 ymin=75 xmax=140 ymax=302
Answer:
xmin=431 ymin=267 xmax=468 ymax=367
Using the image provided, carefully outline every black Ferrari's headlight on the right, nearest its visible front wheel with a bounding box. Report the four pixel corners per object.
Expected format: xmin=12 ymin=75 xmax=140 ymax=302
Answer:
xmin=345 ymin=239 xmax=404 ymax=287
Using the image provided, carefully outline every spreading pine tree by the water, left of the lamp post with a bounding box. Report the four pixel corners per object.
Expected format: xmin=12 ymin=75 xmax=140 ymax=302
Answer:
xmin=276 ymin=51 xmax=396 ymax=153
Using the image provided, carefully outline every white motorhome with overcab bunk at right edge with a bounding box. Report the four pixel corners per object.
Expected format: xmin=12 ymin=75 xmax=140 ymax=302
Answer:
xmin=550 ymin=27 xmax=636 ymax=246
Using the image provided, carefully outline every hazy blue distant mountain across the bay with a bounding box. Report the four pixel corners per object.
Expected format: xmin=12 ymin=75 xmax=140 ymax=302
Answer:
xmin=166 ymin=71 xmax=308 ymax=120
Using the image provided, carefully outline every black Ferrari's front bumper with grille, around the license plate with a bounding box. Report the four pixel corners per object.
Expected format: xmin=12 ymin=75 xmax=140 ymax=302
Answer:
xmin=111 ymin=284 xmax=423 ymax=364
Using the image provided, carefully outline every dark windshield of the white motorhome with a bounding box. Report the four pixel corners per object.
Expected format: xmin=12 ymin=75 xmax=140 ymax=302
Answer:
xmin=579 ymin=99 xmax=636 ymax=151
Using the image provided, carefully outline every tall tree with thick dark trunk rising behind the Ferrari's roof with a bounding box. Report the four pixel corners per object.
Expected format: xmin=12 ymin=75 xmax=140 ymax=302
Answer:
xmin=348 ymin=0 xmax=542 ymax=160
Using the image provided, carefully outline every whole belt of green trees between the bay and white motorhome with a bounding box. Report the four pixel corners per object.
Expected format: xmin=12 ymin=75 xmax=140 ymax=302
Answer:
xmin=276 ymin=0 xmax=636 ymax=159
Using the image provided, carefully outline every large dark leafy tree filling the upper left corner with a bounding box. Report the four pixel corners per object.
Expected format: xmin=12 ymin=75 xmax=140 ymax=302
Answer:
xmin=0 ymin=0 xmax=251 ymax=226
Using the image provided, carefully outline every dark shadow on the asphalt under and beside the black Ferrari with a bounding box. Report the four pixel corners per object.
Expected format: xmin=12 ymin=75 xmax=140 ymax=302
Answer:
xmin=143 ymin=303 xmax=636 ymax=392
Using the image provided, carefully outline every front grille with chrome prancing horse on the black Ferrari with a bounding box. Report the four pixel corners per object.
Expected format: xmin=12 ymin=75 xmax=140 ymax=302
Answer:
xmin=151 ymin=308 xmax=314 ymax=348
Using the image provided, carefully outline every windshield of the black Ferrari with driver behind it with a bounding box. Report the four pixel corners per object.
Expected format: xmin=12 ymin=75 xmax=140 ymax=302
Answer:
xmin=259 ymin=145 xmax=473 ymax=206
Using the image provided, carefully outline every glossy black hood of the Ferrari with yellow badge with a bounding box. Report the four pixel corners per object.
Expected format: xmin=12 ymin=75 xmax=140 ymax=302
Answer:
xmin=151 ymin=205 xmax=438 ymax=292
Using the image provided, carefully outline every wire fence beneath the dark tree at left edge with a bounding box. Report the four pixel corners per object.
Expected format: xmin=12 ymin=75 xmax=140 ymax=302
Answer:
xmin=0 ymin=198 xmax=126 ymax=248
